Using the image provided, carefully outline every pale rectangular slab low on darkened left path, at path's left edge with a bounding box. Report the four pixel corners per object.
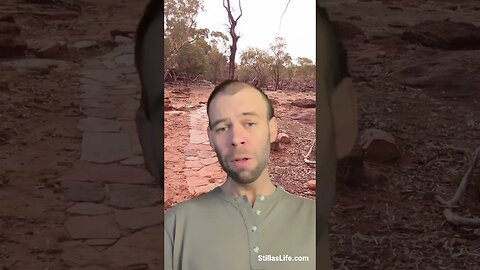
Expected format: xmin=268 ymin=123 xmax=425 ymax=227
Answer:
xmin=65 ymin=215 xmax=120 ymax=239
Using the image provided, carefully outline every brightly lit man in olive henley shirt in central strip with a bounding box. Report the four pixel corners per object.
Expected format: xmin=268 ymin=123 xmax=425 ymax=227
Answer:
xmin=165 ymin=80 xmax=315 ymax=270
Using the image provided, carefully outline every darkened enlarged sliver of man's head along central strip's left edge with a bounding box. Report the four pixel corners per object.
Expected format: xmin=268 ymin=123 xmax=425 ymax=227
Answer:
xmin=135 ymin=0 xmax=164 ymax=189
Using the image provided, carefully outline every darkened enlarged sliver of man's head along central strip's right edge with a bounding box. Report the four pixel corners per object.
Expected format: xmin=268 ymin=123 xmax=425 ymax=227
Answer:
xmin=316 ymin=0 xmax=358 ymax=270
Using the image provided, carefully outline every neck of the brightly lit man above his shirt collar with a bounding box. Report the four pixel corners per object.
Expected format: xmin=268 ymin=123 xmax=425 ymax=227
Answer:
xmin=220 ymin=174 xmax=276 ymax=206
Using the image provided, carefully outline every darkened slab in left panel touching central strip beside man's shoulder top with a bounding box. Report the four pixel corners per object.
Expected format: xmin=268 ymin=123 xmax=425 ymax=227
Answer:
xmin=115 ymin=205 xmax=164 ymax=230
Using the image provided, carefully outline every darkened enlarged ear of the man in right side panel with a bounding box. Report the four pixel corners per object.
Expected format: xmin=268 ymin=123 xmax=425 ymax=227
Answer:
xmin=330 ymin=77 xmax=358 ymax=159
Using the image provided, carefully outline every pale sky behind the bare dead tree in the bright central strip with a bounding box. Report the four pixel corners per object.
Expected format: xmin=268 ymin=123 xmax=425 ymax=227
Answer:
xmin=197 ymin=0 xmax=316 ymax=62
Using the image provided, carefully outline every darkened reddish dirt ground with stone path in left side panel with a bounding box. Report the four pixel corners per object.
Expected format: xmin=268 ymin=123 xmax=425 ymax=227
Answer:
xmin=0 ymin=1 xmax=163 ymax=269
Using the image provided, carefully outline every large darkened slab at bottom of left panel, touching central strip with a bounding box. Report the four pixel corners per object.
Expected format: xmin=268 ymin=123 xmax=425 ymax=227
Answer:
xmin=103 ymin=227 xmax=163 ymax=269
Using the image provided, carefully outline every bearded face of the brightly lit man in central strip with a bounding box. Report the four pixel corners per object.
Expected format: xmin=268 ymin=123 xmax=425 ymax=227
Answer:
xmin=208 ymin=86 xmax=277 ymax=185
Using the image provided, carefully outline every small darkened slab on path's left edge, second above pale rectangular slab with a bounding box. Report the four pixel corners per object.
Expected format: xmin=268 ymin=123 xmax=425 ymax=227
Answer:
xmin=62 ymin=181 xmax=105 ymax=202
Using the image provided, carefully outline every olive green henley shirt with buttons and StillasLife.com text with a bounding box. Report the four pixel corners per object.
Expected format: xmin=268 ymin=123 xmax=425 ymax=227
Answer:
xmin=164 ymin=186 xmax=315 ymax=270
